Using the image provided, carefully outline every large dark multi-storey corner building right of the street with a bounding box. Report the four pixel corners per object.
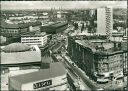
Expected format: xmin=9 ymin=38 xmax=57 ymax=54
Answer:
xmin=67 ymin=36 xmax=128 ymax=82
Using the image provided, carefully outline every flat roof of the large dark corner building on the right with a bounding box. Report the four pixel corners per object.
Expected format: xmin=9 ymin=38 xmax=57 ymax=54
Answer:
xmin=75 ymin=40 xmax=127 ymax=55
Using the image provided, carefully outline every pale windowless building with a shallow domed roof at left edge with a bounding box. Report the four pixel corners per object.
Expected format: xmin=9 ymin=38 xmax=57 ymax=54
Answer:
xmin=1 ymin=43 xmax=41 ymax=66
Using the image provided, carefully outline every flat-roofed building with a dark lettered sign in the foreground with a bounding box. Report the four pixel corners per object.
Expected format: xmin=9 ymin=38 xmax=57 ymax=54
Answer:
xmin=9 ymin=62 xmax=67 ymax=91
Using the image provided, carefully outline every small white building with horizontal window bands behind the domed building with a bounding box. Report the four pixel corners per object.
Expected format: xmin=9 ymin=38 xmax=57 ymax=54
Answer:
xmin=21 ymin=32 xmax=48 ymax=46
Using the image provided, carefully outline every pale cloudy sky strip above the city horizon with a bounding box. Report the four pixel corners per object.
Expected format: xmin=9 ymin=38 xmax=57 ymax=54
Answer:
xmin=0 ymin=1 xmax=127 ymax=10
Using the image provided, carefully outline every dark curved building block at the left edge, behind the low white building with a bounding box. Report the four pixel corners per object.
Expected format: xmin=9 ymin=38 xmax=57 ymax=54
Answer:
xmin=0 ymin=21 xmax=42 ymax=37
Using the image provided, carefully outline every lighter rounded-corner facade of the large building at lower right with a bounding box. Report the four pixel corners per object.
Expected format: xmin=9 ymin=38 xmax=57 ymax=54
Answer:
xmin=94 ymin=52 xmax=124 ymax=82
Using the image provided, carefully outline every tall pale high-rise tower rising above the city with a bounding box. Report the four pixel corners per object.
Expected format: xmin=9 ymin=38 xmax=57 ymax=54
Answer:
xmin=97 ymin=7 xmax=113 ymax=39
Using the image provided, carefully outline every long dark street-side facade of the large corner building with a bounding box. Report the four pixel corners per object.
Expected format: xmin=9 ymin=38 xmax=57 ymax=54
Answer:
xmin=67 ymin=38 xmax=94 ymax=77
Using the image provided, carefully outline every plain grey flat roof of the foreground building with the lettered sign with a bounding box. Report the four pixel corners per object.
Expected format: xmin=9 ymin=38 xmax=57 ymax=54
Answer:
xmin=10 ymin=62 xmax=66 ymax=85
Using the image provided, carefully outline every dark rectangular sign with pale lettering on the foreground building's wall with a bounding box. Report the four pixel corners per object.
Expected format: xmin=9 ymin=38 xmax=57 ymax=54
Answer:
xmin=33 ymin=80 xmax=52 ymax=89
